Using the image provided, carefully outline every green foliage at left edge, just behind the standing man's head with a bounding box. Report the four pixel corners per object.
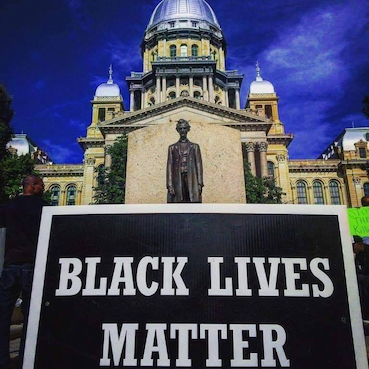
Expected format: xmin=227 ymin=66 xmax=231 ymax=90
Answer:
xmin=0 ymin=154 xmax=37 ymax=204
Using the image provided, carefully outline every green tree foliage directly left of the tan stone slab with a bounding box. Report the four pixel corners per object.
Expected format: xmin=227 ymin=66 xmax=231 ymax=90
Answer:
xmin=94 ymin=135 xmax=128 ymax=204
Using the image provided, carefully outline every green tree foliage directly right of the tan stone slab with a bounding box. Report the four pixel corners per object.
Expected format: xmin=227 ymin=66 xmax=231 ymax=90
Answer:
xmin=244 ymin=160 xmax=284 ymax=204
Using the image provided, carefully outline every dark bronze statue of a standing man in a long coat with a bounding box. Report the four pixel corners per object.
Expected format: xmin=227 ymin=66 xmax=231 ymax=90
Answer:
xmin=167 ymin=119 xmax=204 ymax=203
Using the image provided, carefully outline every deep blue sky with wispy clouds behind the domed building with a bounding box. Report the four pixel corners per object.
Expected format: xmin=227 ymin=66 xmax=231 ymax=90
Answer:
xmin=0 ymin=0 xmax=369 ymax=163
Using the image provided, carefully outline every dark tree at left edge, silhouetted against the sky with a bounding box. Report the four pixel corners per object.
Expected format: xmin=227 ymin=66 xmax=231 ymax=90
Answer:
xmin=0 ymin=85 xmax=14 ymax=161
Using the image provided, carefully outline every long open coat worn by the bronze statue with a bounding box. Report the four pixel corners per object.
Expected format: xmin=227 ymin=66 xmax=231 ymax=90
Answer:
xmin=167 ymin=141 xmax=204 ymax=203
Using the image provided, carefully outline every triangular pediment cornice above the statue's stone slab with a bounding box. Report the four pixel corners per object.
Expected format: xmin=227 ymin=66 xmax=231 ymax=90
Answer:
xmin=99 ymin=97 xmax=272 ymax=135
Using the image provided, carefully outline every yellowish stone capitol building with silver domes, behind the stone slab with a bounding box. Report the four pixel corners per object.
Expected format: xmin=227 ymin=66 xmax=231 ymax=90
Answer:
xmin=33 ymin=0 xmax=369 ymax=207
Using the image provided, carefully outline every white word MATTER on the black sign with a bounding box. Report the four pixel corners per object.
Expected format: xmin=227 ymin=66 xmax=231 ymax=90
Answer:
xmin=100 ymin=323 xmax=290 ymax=368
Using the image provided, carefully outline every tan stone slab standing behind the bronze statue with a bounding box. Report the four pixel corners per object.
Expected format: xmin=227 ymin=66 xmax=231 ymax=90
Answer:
xmin=126 ymin=121 xmax=246 ymax=204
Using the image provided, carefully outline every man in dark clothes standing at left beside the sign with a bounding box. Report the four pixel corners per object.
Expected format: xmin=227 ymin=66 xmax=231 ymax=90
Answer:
xmin=0 ymin=175 xmax=46 ymax=369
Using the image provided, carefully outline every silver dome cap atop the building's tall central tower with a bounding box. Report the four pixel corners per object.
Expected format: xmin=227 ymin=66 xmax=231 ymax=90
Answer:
xmin=147 ymin=0 xmax=220 ymax=30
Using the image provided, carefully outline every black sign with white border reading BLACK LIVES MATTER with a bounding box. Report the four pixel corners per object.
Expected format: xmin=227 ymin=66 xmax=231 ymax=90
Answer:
xmin=24 ymin=205 xmax=366 ymax=369
